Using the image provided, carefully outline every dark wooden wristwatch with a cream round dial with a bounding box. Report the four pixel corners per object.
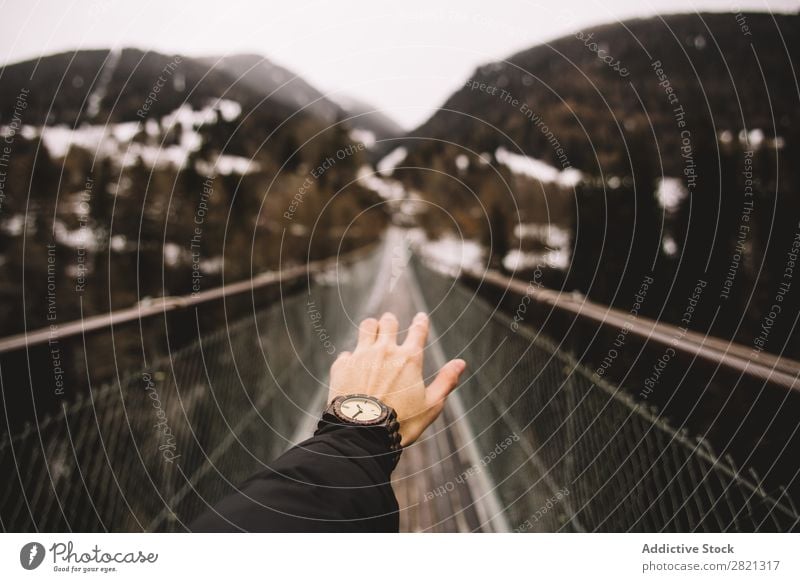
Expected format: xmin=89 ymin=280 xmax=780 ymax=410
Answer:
xmin=320 ymin=394 xmax=403 ymax=467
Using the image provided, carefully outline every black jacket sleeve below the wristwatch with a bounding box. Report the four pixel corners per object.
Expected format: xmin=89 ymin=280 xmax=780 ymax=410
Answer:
xmin=189 ymin=422 xmax=399 ymax=532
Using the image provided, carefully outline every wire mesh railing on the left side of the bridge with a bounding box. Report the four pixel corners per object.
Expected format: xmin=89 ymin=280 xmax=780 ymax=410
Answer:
xmin=0 ymin=252 xmax=379 ymax=531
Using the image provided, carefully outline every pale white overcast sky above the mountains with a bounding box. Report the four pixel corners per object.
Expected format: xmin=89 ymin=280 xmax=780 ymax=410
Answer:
xmin=0 ymin=0 xmax=800 ymax=128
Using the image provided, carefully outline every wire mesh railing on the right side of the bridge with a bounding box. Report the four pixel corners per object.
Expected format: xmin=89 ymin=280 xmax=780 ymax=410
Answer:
xmin=414 ymin=259 xmax=800 ymax=532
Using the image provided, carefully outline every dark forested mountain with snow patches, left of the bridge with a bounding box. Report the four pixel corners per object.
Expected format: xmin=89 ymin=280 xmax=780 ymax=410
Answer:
xmin=0 ymin=48 xmax=387 ymax=334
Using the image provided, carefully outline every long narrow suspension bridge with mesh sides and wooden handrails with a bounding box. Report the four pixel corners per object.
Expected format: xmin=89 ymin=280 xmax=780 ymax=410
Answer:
xmin=0 ymin=228 xmax=800 ymax=532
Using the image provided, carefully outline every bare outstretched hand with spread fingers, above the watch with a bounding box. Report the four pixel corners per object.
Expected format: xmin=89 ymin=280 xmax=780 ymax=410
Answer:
xmin=328 ymin=313 xmax=466 ymax=447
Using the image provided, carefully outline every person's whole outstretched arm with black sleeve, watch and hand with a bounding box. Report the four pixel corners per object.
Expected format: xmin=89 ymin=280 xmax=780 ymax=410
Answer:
xmin=191 ymin=313 xmax=466 ymax=532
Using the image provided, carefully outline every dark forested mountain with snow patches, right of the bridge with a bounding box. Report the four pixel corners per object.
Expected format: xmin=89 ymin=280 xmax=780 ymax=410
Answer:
xmin=379 ymin=13 xmax=800 ymax=357
